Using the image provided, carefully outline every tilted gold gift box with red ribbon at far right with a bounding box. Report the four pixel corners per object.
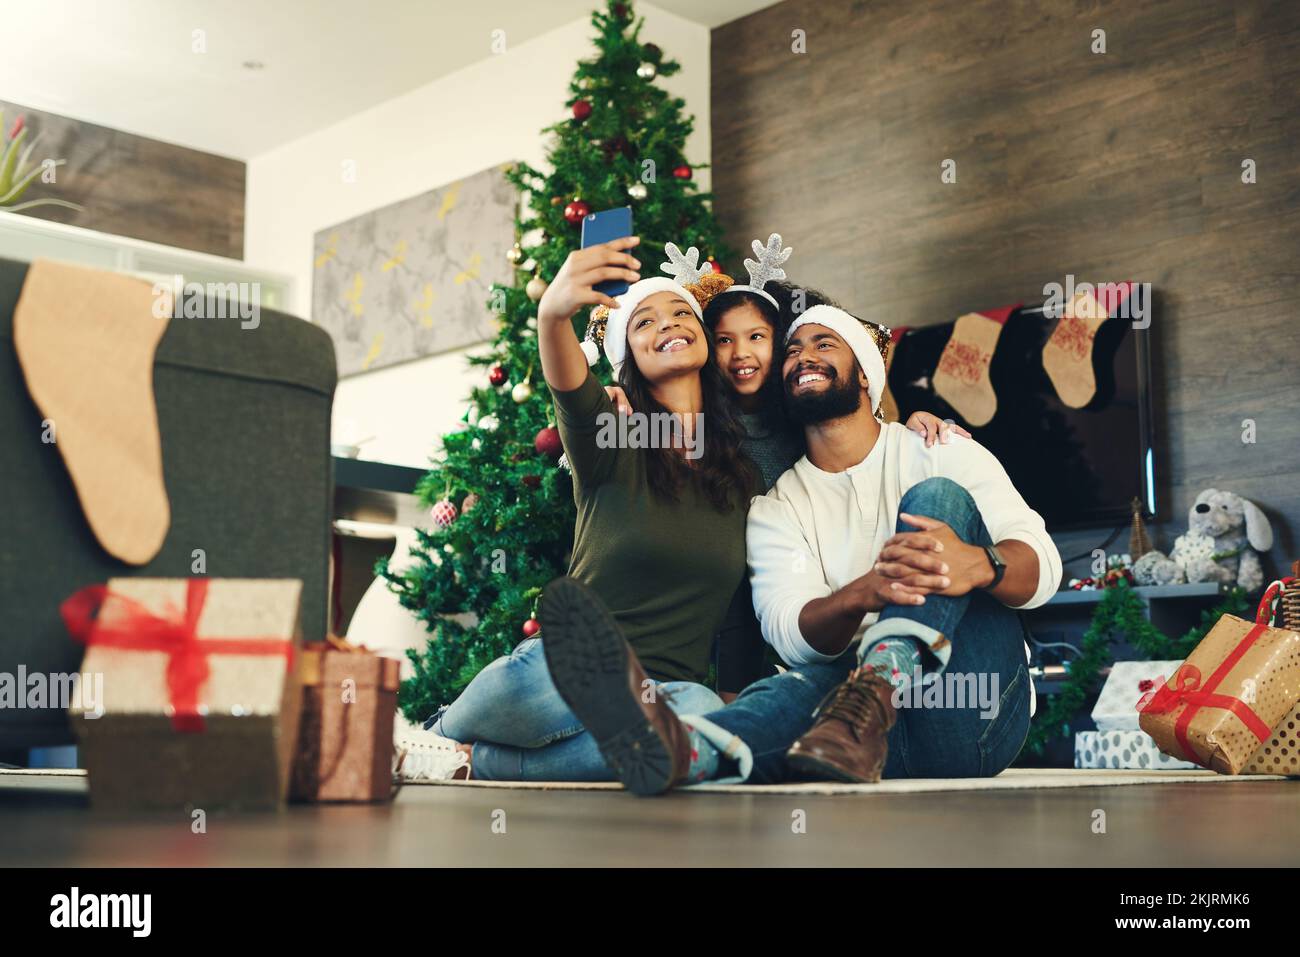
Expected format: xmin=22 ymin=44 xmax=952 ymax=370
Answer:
xmin=1138 ymin=615 xmax=1300 ymax=774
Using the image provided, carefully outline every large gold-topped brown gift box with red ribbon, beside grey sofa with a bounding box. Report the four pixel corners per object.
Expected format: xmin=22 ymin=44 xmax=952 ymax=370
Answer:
xmin=65 ymin=579 xmax=303 ymax=810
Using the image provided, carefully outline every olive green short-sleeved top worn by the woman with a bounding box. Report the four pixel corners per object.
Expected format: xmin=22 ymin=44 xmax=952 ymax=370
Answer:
xmin=553 ymin=372 xmax=749 ymax=683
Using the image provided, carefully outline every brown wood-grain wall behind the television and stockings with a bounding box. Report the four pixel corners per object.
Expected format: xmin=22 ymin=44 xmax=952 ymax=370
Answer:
xmin=712 ymin=0 xmax=1300 ymax=571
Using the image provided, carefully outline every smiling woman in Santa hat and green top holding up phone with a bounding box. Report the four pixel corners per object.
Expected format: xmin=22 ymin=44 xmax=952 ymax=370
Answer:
xmin=426 ymin=237 xmax=761 ymax=780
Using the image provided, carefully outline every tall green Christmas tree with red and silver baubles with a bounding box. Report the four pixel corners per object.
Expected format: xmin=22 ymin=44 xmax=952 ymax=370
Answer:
xmin=378 ymin=3 xmax=723 ymax=720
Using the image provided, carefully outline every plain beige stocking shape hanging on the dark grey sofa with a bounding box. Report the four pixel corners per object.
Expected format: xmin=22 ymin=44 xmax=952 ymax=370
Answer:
xmin=13 ymin=260 xmax=172 ymax=564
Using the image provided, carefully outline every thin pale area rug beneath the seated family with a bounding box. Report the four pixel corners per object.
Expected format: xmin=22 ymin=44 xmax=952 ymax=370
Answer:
xmin=406 ymin=767 xmax=1300 ymax=794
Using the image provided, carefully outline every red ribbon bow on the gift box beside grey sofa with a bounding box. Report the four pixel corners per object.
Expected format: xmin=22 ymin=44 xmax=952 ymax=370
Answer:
xmin=59 ymin=579 xmax=294 ymax=732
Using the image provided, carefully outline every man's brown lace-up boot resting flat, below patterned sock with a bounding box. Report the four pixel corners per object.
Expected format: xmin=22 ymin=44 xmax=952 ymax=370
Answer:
xmin=785 ymin=667 xmax=898 ymax=784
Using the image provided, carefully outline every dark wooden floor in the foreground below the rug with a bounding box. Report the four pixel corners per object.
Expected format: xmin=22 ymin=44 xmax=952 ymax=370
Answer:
xmin=0 ymin=778 xmax=1300 ymax=867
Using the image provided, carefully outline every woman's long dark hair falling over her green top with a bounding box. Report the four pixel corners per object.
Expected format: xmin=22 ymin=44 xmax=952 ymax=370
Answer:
xmin=619 ymin=312 xmax=762 ymax=512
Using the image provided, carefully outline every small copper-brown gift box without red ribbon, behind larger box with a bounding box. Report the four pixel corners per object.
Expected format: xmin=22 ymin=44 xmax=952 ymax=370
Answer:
xmin=291 ymin=638 xmax=402 ymax=801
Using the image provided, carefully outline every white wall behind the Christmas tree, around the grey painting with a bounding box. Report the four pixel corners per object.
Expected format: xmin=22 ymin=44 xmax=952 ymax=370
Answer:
xmin=244 ymin=3 xmax=711 ymax=467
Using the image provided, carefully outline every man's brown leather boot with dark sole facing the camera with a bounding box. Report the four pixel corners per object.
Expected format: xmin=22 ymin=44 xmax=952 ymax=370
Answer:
xmin=538 ymin=579 xmax=690 ymax=796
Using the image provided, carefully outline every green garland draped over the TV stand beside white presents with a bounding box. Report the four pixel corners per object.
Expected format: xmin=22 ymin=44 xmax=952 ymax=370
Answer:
xmin=1024 ymin=581 xmax=1249 ymax=754
